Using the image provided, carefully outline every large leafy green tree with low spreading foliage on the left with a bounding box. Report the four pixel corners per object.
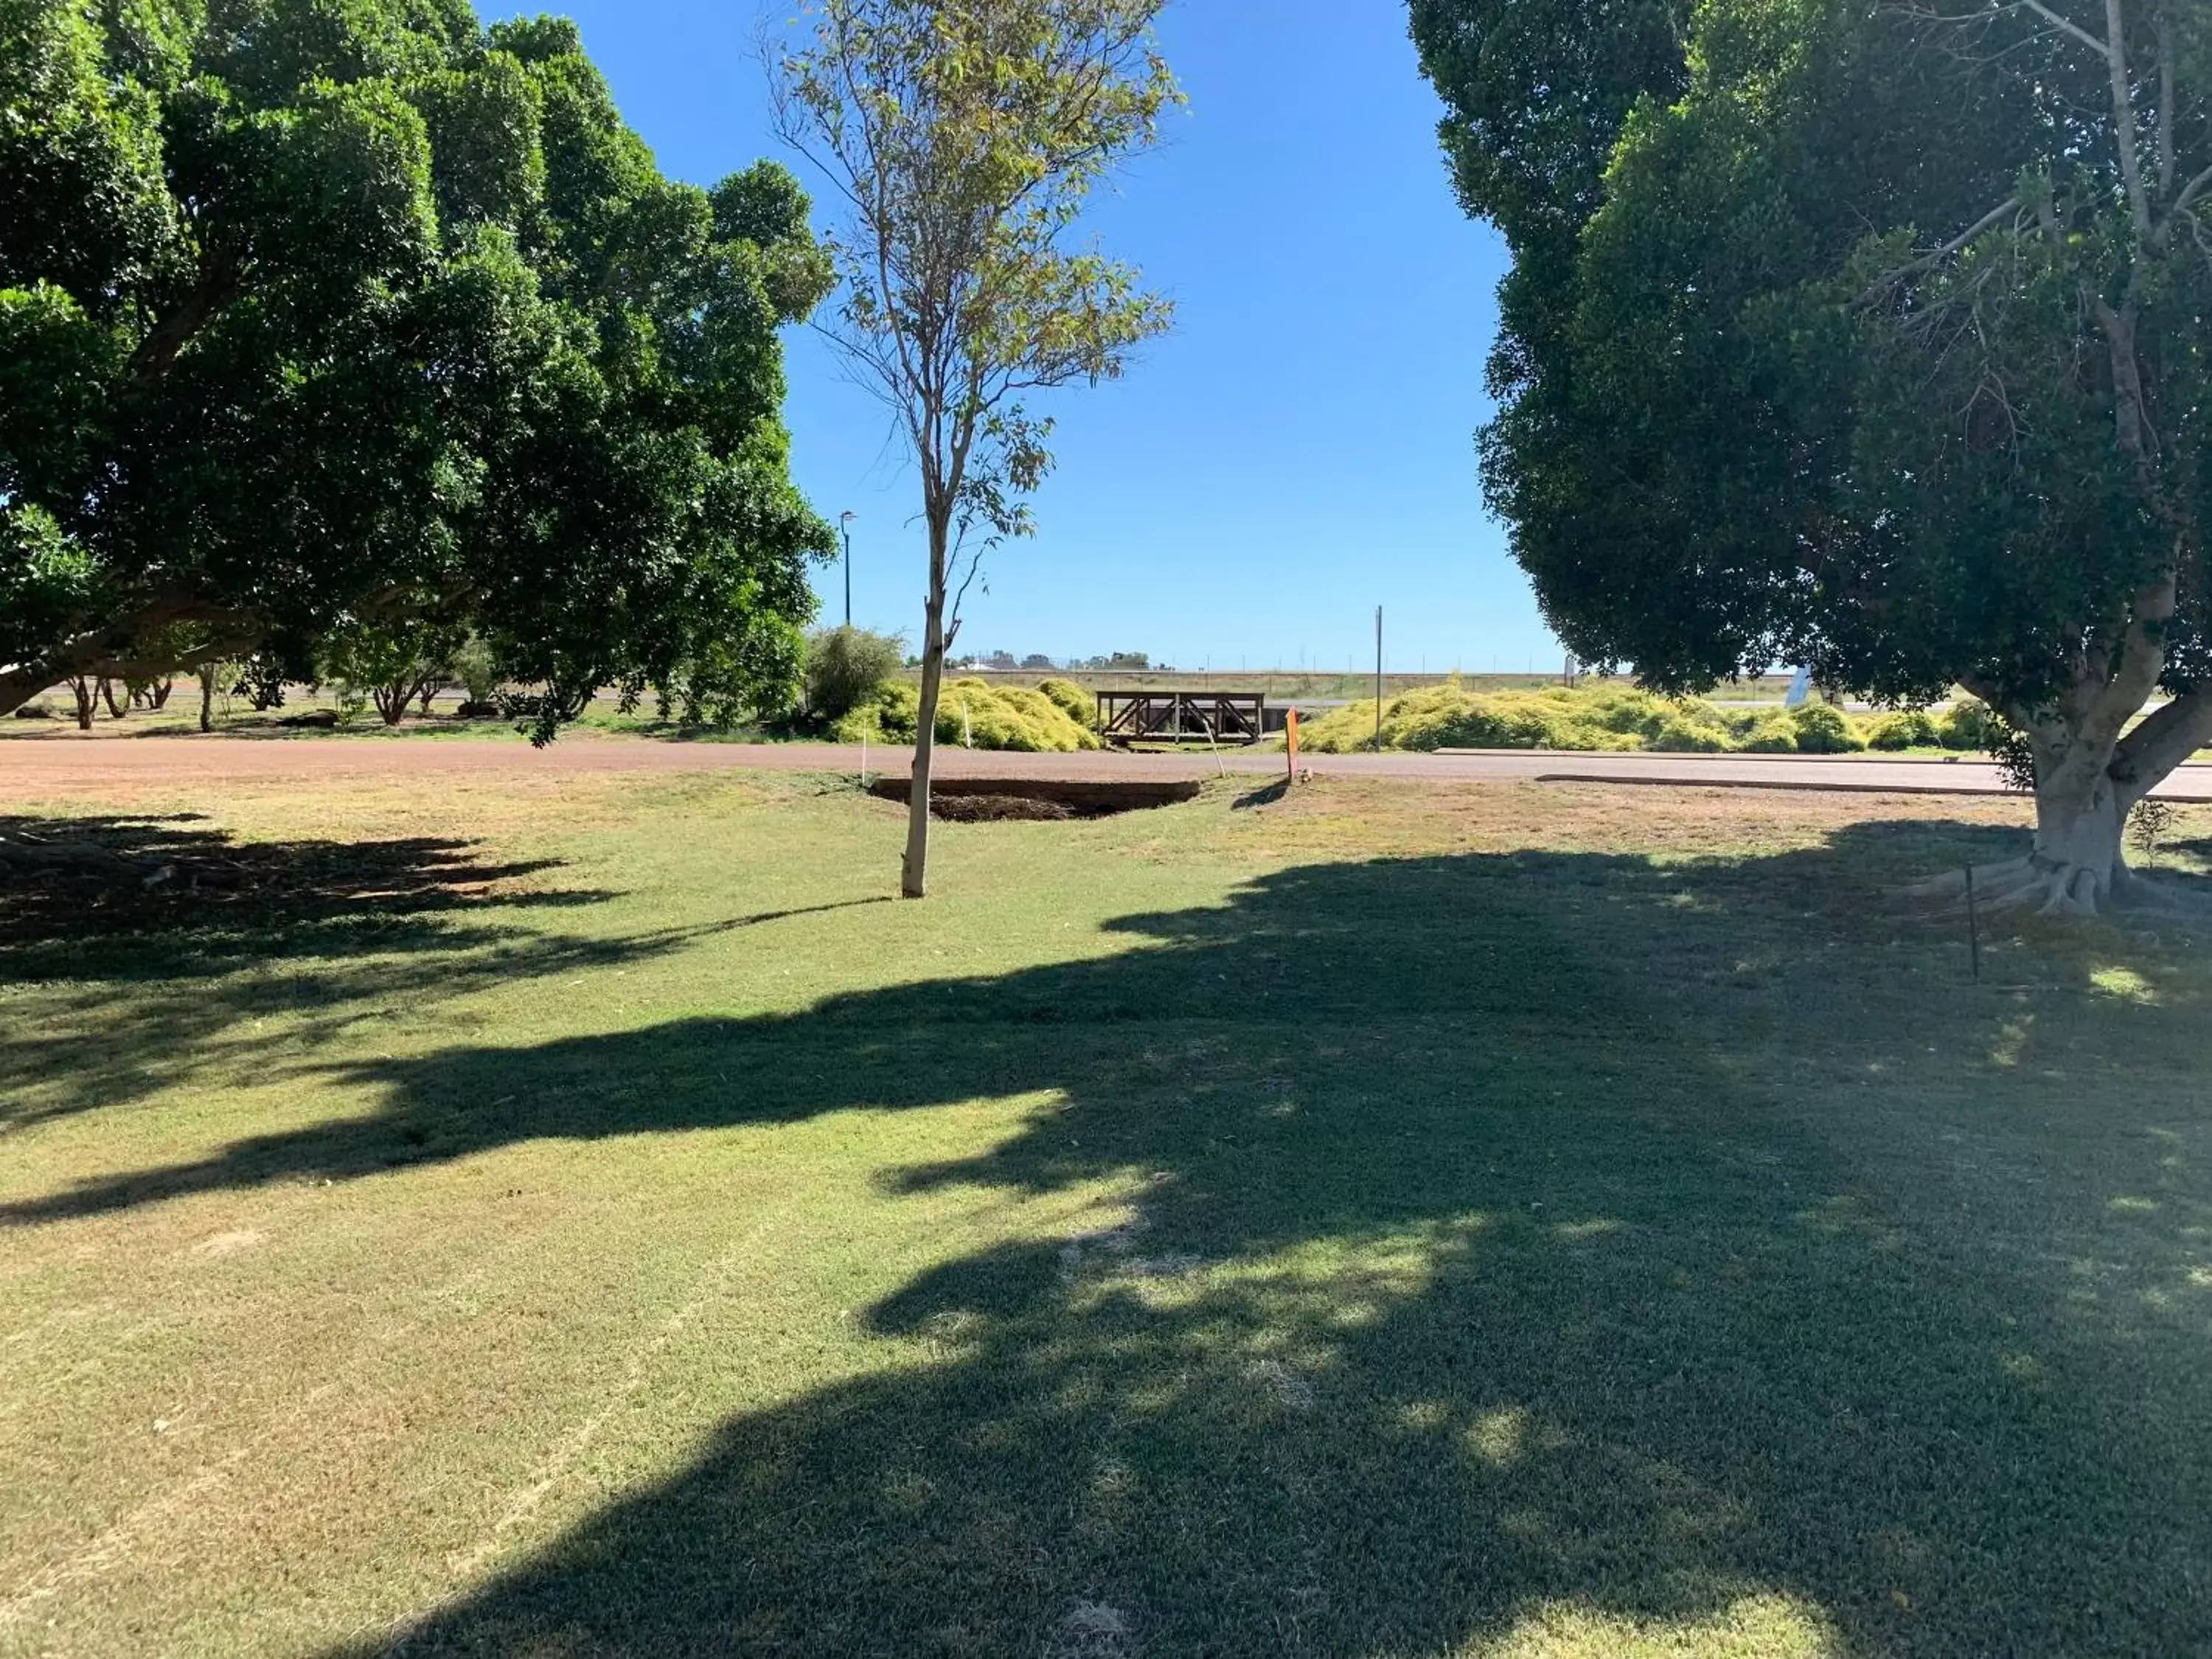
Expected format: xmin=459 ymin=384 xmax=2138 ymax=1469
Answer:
xmin=0 ymin=0 xmax=832 ymax=737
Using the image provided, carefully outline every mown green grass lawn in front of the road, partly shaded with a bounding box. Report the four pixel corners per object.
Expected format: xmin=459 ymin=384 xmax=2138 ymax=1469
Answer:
xmin=0 ymin=779 xmax=2212 ymax=1659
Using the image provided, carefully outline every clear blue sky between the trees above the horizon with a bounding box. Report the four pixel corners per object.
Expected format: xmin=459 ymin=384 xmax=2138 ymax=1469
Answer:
xmin=480 ymin=0 xmax=1559 ymax=672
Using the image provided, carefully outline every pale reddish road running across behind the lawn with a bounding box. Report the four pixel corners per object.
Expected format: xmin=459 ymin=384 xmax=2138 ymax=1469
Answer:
xmin=13 ymin=732 xmax=2212 ymax=801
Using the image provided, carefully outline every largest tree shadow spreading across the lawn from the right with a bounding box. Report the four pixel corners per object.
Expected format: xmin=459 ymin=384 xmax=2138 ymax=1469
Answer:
xmin=26 ymin=827 xmax=2212 ymax=1659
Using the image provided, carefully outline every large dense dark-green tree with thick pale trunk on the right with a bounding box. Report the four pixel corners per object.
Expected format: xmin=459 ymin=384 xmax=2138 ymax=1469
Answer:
xmin=1416 ymin=0 xmax=2212 ymax=909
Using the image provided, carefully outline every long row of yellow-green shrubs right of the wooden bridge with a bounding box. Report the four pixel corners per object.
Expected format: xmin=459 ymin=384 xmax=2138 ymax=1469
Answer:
xmin=1301 ymin=681 xmax=1991 ymax=754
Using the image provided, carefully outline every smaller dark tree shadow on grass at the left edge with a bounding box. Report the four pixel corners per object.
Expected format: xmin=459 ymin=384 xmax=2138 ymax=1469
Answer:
xmin=0 ymin=814 xmax=699 ymax=1133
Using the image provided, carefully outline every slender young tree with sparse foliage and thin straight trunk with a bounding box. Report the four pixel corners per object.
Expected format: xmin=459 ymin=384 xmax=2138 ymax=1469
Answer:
xmin=779 ymin=0 xmax=1177 ymax=898
